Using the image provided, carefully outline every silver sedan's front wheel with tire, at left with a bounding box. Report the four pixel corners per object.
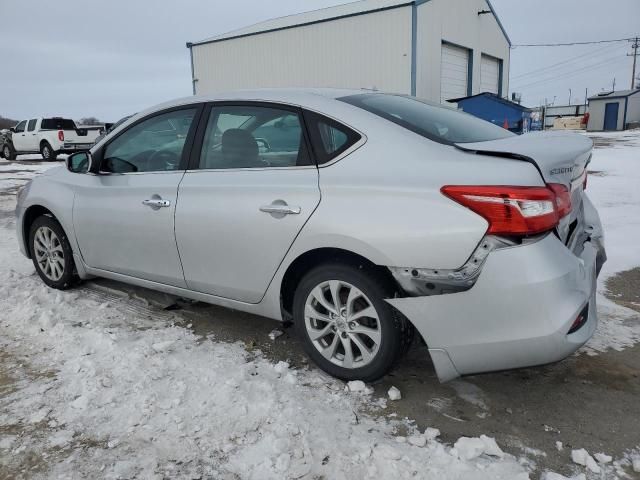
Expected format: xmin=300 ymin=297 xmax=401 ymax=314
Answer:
xmin=29 ymin=215 xmax=76 ymax=290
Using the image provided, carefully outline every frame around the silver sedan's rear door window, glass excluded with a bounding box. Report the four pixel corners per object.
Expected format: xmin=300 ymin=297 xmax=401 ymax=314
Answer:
xmin=187 ymin=100 xmax=318 ymax=173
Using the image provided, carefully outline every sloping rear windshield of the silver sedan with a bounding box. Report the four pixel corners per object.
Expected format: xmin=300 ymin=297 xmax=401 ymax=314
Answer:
xmin=339 ymin=93 xmax=514 ymax=145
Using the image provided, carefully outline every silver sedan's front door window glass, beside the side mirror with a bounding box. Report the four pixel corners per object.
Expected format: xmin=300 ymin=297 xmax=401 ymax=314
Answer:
xmin=100 ymin=108 xmax=197 ymax=173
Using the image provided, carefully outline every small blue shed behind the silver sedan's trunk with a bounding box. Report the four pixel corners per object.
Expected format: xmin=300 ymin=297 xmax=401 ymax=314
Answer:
xmin=449 ymin=92 xmax=533 ymax=133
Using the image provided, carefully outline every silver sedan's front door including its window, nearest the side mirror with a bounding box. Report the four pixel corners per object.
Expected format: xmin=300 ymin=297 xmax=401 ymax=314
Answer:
xmin=73 ymin=106 xmax=199 ymax=287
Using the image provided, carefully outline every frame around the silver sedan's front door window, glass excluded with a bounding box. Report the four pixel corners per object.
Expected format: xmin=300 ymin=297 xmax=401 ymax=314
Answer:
xmin=87 ymin=102 xmax=205 ymax=175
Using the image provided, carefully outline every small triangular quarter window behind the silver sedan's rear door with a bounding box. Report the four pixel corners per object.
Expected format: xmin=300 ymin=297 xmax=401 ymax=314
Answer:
xmin=304 ymin=112 xmax=362 ymax=165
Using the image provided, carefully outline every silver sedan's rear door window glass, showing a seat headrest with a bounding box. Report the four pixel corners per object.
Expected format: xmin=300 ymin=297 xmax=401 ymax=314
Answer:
xmin=199 ymin=105 xmax=312 ymax=170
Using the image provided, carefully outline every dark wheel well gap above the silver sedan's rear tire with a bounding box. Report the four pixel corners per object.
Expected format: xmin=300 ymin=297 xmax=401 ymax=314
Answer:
xmin=280 ymin=248 xmax=402 ymax=321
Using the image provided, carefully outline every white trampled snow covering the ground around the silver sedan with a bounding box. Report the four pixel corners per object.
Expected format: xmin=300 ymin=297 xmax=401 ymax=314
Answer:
xmin=0 ymin=133 xmax=640 ymax=480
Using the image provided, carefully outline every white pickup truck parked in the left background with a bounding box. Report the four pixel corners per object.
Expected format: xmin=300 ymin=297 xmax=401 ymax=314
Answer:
xmin=0 ymin=117 xmax=102 ymax=160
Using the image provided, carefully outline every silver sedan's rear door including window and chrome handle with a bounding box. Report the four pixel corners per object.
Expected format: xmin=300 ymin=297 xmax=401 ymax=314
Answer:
xmin=176 ymin=103 xmax=320 ymax=303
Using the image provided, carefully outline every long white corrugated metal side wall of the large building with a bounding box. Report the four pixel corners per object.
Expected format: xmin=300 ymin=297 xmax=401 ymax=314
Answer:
xmin=192 ymin=6 xmax=412 ymax=94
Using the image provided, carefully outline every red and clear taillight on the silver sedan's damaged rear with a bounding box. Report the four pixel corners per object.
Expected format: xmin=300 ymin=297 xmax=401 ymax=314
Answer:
xmin=441 ymin=185 xmax=560 ymax=235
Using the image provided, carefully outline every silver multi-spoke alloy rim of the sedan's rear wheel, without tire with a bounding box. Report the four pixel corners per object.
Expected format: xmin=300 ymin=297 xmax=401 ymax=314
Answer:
xmin=304 ymin=280 xmax=382 ymax=369
